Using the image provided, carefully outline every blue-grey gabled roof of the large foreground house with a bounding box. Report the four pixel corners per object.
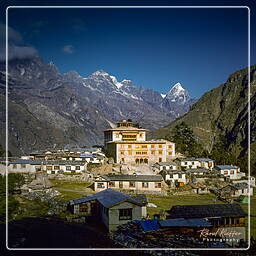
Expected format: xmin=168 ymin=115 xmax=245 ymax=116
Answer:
xmin=70 ymin=188 xmax=142 ymax=208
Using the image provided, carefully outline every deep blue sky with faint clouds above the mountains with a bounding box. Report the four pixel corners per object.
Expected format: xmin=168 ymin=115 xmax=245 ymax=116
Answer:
xmin=0 ymin=2 xmax=255 ymax=98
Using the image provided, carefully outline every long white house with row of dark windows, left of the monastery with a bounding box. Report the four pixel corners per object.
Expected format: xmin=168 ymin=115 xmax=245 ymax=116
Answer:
xmin=42 ymin=160 xmax=87 ymax=174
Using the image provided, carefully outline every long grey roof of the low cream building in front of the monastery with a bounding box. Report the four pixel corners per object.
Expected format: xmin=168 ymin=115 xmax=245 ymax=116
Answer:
xmin=102 ymin=174 xmax=163 ymax=182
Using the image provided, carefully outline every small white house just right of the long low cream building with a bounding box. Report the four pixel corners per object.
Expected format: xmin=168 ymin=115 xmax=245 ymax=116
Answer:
xmin=160 ymin=170 xmax=187 ymax=187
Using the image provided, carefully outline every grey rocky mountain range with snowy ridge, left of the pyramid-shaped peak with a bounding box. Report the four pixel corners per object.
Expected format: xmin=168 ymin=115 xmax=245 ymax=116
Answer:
xmin=0 ymin=57 xmax=195 ymax=154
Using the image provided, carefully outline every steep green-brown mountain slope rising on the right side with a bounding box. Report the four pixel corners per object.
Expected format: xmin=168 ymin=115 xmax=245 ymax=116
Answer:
xmin=151 ymin=65 xmax=256 ymax=172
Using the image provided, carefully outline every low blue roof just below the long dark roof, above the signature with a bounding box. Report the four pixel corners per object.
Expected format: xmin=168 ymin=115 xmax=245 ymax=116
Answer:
xmin=159 ymin=218 xmax=212 ymax=227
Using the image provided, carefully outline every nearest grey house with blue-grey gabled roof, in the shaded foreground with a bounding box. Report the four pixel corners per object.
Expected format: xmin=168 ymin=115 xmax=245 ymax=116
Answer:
xmin=69 ymin=189 xmax=147 ymax=231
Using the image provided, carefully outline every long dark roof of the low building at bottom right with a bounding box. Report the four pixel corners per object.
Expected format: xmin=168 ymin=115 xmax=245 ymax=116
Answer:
xmin=168 ymin=204 xmax=246 ymax=218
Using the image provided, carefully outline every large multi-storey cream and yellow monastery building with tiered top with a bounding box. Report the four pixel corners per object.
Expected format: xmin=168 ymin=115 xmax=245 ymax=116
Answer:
xmin=104 ymin=120 xmax=175 ymax=164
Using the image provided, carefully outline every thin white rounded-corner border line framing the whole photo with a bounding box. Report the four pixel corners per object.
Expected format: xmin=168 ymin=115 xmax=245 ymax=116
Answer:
xmin=5 ymin=6 xmax=251 ymax=251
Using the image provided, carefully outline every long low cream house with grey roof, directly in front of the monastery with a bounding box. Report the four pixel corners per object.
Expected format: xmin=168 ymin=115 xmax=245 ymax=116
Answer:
xmin=94 ymin=174 xmax=163 ymax=192
